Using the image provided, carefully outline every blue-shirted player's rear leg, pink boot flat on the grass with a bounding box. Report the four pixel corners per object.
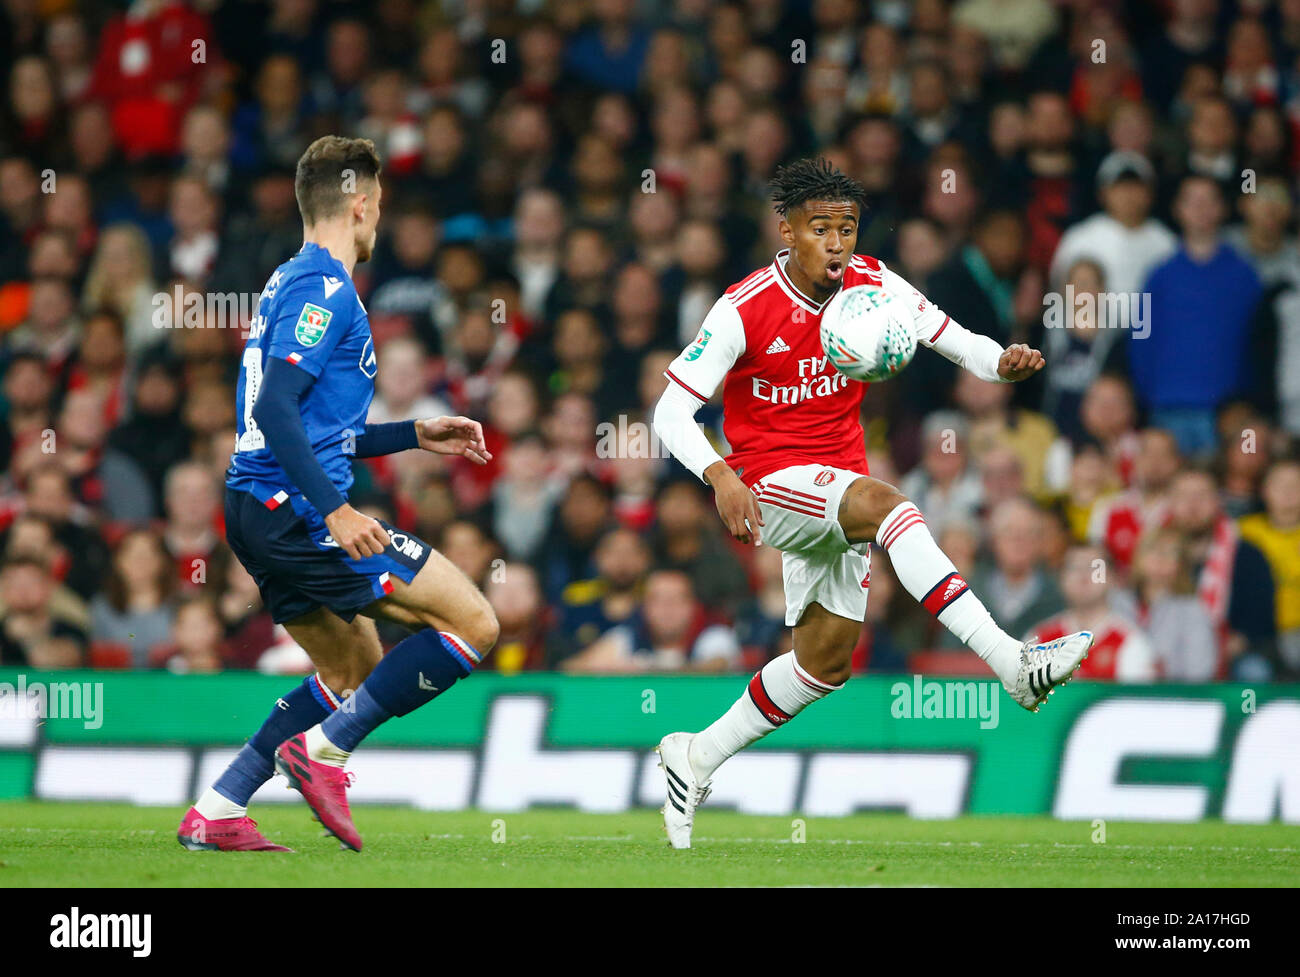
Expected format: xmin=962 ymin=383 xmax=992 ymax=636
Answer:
xmin=177 ymin=607 xmax=384 ymax=851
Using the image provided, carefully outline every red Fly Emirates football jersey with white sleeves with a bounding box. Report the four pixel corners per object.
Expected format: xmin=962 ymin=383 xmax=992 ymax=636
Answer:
xmin=664 ymin=249 xmax=948 ymax=485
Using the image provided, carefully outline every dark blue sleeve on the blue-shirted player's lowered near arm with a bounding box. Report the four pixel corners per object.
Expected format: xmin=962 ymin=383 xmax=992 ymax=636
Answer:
xmin=252 ymin=356 xmax=345 ymax=517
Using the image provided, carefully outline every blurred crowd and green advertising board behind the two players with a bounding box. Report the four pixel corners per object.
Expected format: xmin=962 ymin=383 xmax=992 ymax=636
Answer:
xmin=0 ymin=0 xmax=1300 ymax=821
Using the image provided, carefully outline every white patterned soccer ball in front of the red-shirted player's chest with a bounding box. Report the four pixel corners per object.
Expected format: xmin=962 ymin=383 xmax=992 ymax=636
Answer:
xmin=822 ymin=285 xmax=917 ymax=383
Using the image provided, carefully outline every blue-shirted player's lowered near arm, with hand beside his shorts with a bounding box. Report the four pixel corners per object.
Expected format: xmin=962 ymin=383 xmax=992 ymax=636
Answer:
xmin=252 ymin=357 xmax=389 ymax=560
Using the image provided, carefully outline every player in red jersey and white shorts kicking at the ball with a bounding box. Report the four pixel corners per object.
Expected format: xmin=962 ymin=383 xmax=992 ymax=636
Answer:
xmin=654 ymin=159 xmax=1092 ymax=848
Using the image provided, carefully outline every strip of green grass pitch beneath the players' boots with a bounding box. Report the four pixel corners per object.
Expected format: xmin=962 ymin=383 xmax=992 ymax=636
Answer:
xmin=0 ymin=802 xmax=1300 ymax=887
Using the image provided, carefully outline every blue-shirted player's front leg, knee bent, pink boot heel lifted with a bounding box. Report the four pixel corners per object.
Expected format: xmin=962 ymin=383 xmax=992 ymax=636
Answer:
xmin=276 ymin=551 xmax=499 ymax=851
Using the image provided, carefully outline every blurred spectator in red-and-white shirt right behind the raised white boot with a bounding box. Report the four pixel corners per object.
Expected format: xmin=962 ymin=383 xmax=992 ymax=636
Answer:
xmin=1026 ymin=544 xmax=1158 ymax=682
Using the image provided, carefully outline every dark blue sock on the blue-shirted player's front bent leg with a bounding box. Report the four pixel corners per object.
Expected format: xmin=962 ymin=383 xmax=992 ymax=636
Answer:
xmin=321 ymin=628 xmax=480 ymax=754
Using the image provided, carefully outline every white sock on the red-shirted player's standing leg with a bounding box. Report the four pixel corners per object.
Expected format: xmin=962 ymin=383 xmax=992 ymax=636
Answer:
xmin=688 ymin=651 xmax=841 ymax=782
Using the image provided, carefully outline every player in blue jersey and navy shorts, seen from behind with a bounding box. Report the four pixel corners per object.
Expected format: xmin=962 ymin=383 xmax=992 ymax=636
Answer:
xmin=177 ymin=136 xmax=498 ymax=851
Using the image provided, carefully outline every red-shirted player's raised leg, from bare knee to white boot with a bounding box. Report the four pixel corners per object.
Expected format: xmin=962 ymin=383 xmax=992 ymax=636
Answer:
xmin=840 ymin=477 xmax=1092 ymax=712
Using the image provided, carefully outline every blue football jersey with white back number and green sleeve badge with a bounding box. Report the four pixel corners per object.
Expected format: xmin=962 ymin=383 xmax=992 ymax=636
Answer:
xmin=226 ymin=243 xmax=377 ymax=518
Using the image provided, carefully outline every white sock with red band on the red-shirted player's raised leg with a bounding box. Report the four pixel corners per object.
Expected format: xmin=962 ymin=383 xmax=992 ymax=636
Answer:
xmin=876 ymin=501 xmax=1022 ymax=682
